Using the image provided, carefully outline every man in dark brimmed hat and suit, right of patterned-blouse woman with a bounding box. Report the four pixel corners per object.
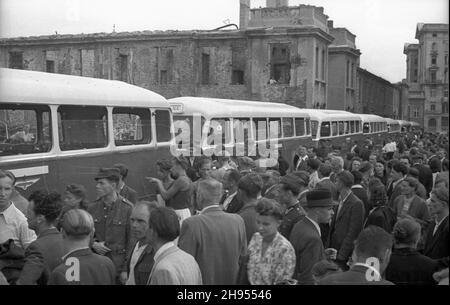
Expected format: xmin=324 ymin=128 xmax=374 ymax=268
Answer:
xmin=289 ymin=189 xmax=335 ymax=285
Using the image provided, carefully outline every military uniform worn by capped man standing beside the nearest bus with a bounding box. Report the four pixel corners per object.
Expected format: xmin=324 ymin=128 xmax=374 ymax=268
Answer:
xmin=88 ymin=195 xmax=133 ymax=274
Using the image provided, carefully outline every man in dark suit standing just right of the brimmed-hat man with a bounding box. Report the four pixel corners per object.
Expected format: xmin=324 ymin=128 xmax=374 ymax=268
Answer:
xmin=329 ymin=171 xmax=365 ymax=270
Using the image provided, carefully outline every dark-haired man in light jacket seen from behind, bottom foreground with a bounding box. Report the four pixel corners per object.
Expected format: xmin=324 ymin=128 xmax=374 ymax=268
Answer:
xmin=148 ymin=207 xmax=202 ymax=285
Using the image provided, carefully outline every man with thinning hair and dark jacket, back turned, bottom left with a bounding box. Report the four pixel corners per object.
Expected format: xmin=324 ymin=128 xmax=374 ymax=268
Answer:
xmin=49 ymin=209 xmax=116 ymax=285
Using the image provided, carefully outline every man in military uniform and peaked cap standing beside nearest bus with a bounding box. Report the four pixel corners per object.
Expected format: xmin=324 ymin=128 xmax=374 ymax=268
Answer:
xmin=88 ymin=168 xmax=133 ymax=284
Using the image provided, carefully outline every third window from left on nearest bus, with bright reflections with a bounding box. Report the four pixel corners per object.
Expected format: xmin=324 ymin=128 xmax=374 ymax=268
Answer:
xmin=113 ymin=108 xmax=152 ymax=146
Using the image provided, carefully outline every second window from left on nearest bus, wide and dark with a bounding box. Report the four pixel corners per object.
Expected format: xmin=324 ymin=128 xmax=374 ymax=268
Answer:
xmin=58 ymin=106 xmax=108 ymax=151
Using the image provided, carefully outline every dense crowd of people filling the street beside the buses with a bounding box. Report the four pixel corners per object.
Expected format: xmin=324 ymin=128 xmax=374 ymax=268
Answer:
xmin=0 ymin=129 xmax=449 ymax=285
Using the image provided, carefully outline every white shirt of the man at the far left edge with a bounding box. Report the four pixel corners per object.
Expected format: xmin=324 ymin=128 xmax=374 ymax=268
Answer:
xmin=0 ymin=203 xmax=37 ymax=249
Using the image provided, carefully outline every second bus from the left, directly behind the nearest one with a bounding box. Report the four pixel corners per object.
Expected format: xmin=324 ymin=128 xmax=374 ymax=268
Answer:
xmin=169 ymin=97 xmax=311 ymax=164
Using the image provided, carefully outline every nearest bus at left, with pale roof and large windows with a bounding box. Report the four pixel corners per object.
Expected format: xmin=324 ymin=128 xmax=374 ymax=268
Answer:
xmin=0 ymin=69 xmax=173 ymax=200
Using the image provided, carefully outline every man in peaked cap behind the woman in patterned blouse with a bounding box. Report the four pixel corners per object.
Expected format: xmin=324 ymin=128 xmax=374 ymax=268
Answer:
xmin=279 ymin=174 xmax=307 ymax=238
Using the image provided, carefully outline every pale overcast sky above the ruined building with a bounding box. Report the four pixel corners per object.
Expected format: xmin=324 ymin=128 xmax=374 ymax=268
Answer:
xmin=0 ymin=0 xmax=449 ymax=82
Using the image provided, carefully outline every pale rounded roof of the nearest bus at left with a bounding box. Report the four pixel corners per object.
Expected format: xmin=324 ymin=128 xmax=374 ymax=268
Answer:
xmin=0 ymin=68 xmax=169 ymax=108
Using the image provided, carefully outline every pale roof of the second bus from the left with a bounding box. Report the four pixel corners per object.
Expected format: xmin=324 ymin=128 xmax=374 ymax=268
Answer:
xmin=169 ymin=96 xmax=309 ymax=119
